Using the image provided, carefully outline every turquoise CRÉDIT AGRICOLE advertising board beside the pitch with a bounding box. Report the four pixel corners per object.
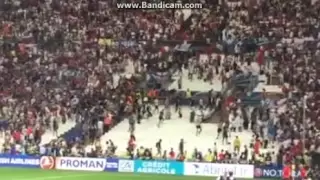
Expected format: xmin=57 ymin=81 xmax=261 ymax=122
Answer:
xmin=134 ymin=160 xmax=184 ymax=175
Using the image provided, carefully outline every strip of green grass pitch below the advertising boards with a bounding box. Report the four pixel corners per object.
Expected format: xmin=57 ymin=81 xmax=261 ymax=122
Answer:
xmin=0 ymin=168 xmax=261 ymax=180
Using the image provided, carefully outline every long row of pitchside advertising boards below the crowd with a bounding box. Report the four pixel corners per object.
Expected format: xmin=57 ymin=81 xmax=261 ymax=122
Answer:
xmin=0 ymin=155 xmax=288 ymax=179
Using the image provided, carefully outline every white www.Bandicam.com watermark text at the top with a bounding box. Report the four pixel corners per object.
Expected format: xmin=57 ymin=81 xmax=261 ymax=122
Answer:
xmin=117 ymin=2 xmax=203 ymax=9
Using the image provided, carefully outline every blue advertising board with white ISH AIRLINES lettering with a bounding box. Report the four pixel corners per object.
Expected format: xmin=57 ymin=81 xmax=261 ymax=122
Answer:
xmin=0 ymin=154 xmax=40 ymax=168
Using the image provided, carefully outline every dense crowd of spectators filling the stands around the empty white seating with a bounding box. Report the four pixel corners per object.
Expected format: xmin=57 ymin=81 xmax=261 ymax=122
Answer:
xmin=0 ymin=0 xmax=320 ymax=179
